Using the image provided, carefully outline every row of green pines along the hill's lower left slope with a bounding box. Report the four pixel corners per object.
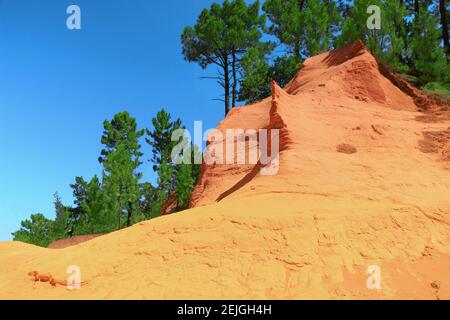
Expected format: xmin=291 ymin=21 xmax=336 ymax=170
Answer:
xmin=13 ymin=110 xmax=200 ymax=247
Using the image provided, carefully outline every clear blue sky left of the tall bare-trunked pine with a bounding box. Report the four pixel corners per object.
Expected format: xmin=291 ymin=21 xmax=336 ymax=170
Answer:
xmin=0 ymin=0 xmax=227 ymax=240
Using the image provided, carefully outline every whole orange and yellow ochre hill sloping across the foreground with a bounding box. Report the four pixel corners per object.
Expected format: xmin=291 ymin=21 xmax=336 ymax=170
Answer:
xmin=0 ymin=42 xmax=450 ymax=299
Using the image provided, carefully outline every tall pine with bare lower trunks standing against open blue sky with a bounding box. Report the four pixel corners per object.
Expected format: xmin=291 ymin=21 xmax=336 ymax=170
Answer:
xmin=181 ymin=0 xmax=265 ymax=115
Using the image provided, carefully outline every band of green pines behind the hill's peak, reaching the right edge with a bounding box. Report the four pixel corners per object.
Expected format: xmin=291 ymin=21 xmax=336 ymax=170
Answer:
xmin=246 ymin=0 xmax=450 ymax=103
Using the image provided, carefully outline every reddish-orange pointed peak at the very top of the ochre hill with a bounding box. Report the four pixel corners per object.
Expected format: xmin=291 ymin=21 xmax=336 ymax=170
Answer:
xmin=285 ymin=41 xmax=417 ymax=111
